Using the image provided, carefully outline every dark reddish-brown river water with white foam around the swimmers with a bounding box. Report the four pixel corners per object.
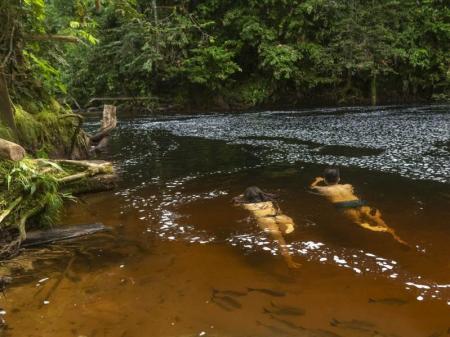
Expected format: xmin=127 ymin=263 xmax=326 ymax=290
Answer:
xmin=2 ymin=106 xmax=450 ymax=337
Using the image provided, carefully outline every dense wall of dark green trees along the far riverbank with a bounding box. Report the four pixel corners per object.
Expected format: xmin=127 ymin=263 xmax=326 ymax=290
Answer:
xmin=60 ymin=0 xmax=450 ymax=108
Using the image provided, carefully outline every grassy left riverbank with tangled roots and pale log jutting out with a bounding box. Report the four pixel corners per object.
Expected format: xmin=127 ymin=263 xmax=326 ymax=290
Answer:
xmin=0 ymin=158 xmax=117 ymax=258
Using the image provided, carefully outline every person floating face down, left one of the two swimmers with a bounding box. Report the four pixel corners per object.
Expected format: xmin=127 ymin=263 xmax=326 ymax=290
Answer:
xmin=233 ymin=186 xmax=301 ymax=268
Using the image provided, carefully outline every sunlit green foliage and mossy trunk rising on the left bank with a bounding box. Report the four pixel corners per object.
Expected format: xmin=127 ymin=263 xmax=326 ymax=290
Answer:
xmin=0 ymin=0 xmax=95 ymax=156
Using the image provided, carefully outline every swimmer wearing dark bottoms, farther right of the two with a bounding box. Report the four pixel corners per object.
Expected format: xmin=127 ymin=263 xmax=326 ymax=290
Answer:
xmin=310 ymin=168 xmax=409 ymax=246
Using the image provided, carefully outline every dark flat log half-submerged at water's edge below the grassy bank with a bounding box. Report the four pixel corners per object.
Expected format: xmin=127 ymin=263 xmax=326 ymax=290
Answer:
xmin=21 ymin=223 xmax=108 ymax=248
